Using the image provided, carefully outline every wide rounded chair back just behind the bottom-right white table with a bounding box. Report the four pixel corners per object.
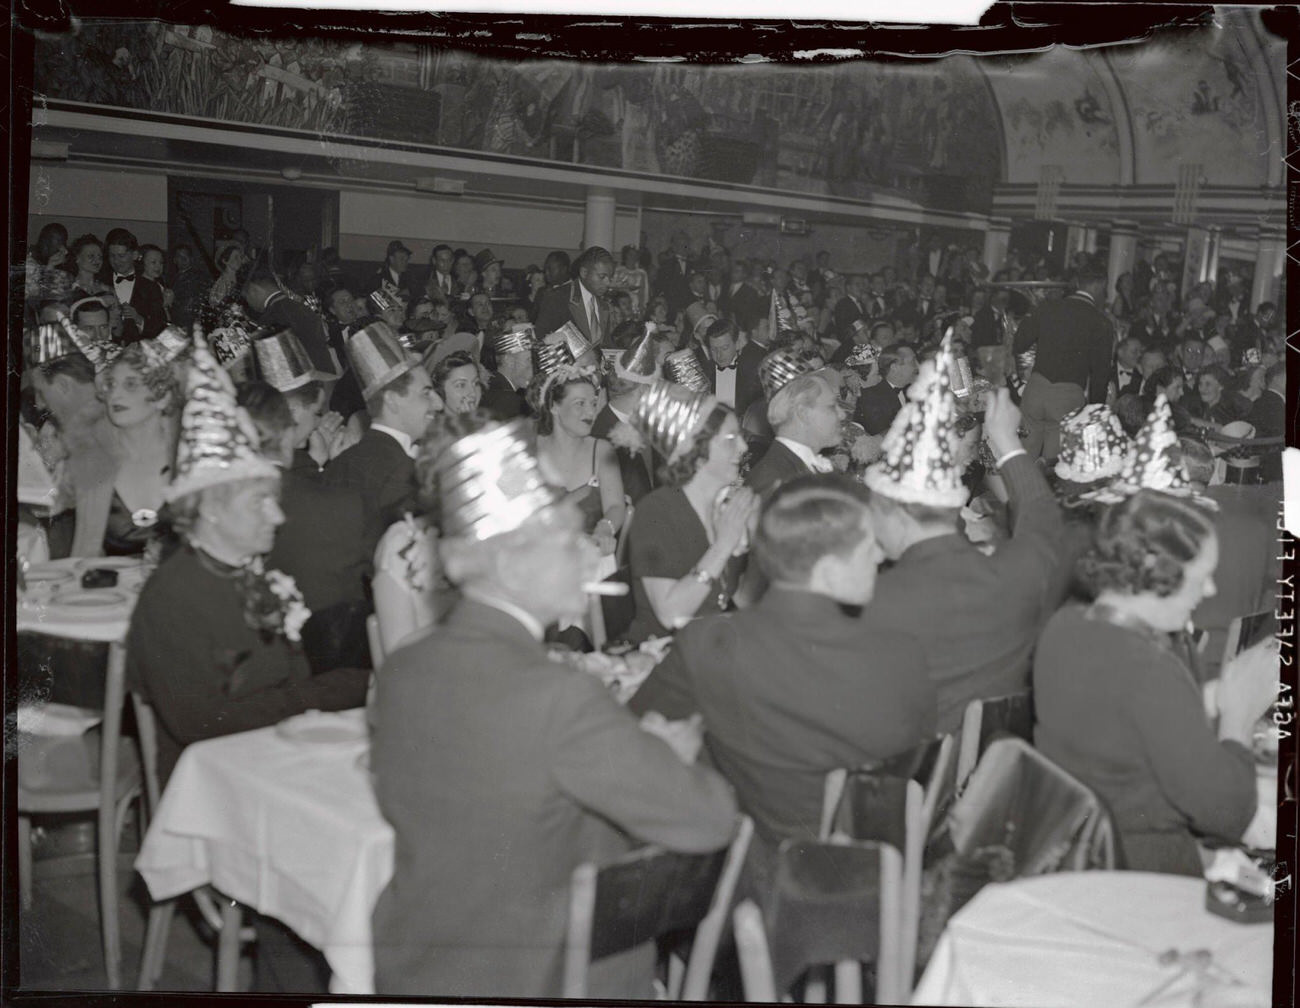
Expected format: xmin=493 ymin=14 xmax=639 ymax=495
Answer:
xmin=948 ymin=737 xmax=1115 ymax=881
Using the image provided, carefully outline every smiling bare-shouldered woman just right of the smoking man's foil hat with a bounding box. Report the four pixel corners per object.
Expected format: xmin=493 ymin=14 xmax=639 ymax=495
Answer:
xmin=528 ymin=364 xmax=625 ymax=551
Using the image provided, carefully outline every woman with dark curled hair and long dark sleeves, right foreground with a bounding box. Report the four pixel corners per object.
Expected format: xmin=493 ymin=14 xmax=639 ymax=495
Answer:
xmin=1034 ymin=490 xmax=1277 ymax=875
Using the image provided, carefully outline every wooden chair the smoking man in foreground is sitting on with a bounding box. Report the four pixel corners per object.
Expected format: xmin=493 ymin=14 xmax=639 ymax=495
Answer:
xmin=563 ymin=816 xmax=754 ymax=1001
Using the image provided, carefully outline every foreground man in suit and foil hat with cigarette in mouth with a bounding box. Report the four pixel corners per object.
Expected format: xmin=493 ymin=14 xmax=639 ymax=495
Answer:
xmin=371 ymin=429 xmax=736 ymax=999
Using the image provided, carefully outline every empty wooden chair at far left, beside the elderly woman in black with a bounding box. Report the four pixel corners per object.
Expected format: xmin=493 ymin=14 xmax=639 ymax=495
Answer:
xmin=17 ymin=641 xmax=144 ymax=990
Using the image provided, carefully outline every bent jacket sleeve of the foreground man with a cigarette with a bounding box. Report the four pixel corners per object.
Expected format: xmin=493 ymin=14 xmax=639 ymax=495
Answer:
xmin=551 ymin=672 xmax=737 ymax=853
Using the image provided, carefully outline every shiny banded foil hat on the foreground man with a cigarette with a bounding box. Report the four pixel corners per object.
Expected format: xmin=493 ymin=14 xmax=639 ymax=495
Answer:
xmin=434 ymin=418 xmax=564 ymax=542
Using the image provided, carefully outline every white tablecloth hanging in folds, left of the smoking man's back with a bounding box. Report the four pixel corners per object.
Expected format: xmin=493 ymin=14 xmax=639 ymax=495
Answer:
xmin=135 ymin=710 xmax=393 ymax=994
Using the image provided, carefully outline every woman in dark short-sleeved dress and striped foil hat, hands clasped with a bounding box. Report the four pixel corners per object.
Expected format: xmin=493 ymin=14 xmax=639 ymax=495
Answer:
xmin=615 ymin=382 xmax=757 ymax=641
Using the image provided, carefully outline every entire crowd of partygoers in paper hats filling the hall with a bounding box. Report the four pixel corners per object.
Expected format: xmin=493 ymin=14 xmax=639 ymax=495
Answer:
xmin=22 ymin=218 xmax=1286 ymax=998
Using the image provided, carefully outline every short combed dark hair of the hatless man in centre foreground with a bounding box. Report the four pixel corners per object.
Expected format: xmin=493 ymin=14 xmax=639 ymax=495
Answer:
xmin=754 ymin=473 xmax=871 ymax=584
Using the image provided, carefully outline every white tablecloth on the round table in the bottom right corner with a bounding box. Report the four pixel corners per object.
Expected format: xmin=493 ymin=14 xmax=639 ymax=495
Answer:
xmin=913 ymin=871 xmax=1273 ymax=1008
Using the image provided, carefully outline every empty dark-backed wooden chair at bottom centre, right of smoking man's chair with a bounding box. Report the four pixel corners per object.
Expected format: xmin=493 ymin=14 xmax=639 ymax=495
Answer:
xmin=733 ymin=840 xmax=902 ymax=1004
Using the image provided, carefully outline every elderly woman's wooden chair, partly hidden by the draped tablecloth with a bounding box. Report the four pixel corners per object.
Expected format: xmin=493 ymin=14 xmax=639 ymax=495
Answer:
xmin=131 ymin=689 xmax=257 ymax=991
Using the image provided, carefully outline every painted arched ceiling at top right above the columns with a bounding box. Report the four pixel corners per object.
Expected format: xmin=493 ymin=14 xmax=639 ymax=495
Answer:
xmin=972 ymin=8 xmax=1286 ymax=186
